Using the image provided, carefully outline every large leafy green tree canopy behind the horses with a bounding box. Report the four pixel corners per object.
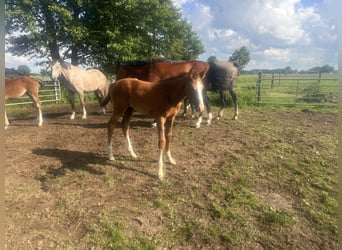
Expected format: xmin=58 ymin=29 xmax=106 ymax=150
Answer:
xmin=5 ymin=0 xmax=204 ymax=72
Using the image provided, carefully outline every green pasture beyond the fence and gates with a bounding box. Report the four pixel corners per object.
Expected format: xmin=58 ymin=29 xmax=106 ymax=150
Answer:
xmin=6 ymin=74 xmax=338 ymax=110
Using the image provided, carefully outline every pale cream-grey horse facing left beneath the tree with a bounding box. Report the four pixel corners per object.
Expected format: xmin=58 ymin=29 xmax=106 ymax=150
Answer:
xmin=52 ymin=60 xmax=109 ymax=119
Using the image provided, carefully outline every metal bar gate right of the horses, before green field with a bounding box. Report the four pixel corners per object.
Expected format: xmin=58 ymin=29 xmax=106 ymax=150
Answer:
xmin=255 ymin=74 xmax=338 ymax=106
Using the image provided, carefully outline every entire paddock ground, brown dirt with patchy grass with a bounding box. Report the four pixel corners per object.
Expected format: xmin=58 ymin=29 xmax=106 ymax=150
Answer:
xmin=5 ymin=106 xmax=338 ymax=249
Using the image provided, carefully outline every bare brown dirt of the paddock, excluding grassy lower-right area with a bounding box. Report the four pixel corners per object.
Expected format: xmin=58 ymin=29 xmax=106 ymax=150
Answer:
xmin=5 ymin=102 xmax=337 ymax=249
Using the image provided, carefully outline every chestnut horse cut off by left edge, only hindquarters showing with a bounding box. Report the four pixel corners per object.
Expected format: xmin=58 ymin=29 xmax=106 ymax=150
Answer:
xmin=5 ymin=76 xmax=43 ymax=129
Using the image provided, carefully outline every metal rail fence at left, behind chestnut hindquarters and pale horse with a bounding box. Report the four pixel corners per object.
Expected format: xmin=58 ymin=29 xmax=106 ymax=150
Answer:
xmin=5 ymin=81 xmax=61 ymax=106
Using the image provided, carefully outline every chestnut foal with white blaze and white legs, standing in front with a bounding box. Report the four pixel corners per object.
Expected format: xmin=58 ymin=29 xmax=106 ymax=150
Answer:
xmin=107 ymin=68 xmax=204 ymax=180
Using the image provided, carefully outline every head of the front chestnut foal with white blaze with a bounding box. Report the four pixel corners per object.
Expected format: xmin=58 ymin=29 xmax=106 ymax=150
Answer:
xmin=187 ymin=68 xmax=204 ymax=112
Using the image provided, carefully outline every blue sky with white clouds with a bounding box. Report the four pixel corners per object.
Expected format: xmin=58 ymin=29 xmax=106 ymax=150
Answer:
xmin=5 ymin=0 xmax=340 ymax=72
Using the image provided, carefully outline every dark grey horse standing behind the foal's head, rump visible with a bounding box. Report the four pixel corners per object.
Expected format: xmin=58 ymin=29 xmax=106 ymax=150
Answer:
xmin=183 ymin=61 xmax=239 ymax=120
